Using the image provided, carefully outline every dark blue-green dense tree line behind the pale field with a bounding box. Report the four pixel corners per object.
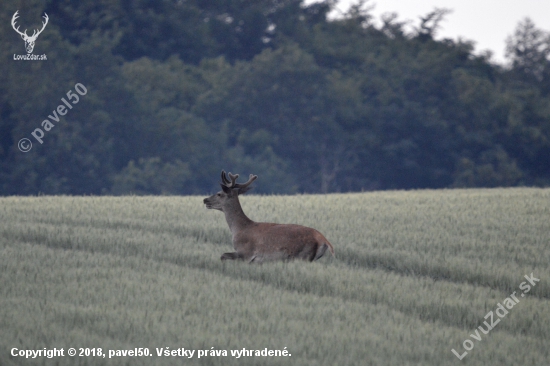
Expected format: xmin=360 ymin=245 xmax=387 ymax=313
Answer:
xmin=0 ymin=0 xmax=550 ymax=195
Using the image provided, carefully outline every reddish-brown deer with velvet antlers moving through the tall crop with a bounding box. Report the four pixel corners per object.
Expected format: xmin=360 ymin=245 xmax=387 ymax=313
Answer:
xmin=203 ymin=170 xmax=334 ymax=263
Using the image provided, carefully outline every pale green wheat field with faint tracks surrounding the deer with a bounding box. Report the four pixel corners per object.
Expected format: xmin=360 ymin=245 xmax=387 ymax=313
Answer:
xmin=0 ymin=188 xmax=550 ymax=366
